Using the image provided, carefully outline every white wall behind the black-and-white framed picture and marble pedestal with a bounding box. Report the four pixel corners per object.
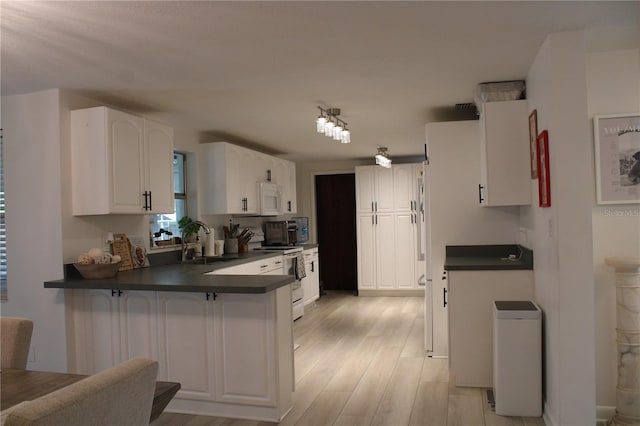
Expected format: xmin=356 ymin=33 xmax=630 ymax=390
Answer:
xmin=586 ymin=49 xmax=640 ymax=407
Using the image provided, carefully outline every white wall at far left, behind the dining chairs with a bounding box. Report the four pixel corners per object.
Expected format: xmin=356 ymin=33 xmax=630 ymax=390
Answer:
xmin=1 ymin=90 xmax=67 ymax=371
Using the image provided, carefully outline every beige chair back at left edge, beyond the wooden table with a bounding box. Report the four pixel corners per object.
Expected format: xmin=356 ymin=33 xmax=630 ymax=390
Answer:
xmin=0 ymin=317 xmax=33 ymax=370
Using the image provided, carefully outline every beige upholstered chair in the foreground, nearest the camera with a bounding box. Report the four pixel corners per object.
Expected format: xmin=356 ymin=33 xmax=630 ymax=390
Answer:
xmin=2 ymin=358 xmax=158 ymax=426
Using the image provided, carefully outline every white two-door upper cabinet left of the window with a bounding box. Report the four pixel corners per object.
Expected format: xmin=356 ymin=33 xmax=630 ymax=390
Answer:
xmin=71 ymin=107 xmax=174 ymax=216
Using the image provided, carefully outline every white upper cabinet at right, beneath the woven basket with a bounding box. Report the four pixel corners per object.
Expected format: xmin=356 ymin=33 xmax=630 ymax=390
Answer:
xmin=478 ymin=100 xmax=531 ymax=206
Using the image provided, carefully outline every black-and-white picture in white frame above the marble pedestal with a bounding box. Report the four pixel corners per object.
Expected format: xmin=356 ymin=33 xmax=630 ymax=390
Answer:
xmin=593 ymin=113 xmax=640 ymax=204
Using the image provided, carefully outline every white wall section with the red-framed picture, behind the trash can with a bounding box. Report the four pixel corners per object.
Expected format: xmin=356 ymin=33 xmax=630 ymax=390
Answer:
xmin=521 ymin=32 xmax=596 ymax=425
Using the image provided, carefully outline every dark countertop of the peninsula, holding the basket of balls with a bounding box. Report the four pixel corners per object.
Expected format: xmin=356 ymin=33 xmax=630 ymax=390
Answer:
xmin=44 ymin=252 xmax=295 ymax=293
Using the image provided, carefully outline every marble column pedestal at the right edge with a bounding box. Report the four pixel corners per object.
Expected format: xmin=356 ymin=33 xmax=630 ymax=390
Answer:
xmin=605 ymin=257 xmax=640 ymax=426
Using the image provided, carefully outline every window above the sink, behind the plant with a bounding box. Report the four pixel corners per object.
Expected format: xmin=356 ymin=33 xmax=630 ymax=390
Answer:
xmin=150 ymin=151 xmax=189 ymax=247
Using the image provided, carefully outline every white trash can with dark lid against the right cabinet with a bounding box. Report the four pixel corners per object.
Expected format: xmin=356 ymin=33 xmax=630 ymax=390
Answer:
xmin=493 ymin=300 xmax=542 ymax=417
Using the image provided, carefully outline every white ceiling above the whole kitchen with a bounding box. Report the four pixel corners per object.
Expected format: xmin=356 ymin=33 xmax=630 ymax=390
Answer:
xmin=0 ymin=0 xmax=640 ymax=161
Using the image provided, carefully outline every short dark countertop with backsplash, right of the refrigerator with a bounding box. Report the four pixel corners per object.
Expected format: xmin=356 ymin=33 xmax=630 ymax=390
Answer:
xmin=444 ymin=244 xmax=533 ymax=271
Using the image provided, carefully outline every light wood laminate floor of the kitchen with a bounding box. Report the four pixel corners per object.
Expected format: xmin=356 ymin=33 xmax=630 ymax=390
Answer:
xmin=152 ymin=293 xmax=544 ymax=426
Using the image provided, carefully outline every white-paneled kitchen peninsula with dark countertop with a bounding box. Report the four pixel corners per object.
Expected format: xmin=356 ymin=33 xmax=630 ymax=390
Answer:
xmin=45 ymin=253 xmax=294 ymax=422
